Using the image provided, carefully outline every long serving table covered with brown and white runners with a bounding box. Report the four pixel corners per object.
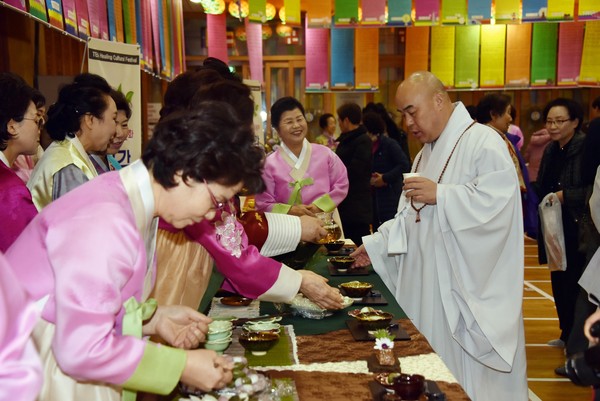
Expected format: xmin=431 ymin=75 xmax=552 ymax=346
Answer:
xmin=204 ymin=248 xmax=469 ymax=401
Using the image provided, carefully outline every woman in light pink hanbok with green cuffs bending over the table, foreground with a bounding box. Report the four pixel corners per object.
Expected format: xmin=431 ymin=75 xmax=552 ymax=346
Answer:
xmin=6 ymin=102 xmax=263 ymax=401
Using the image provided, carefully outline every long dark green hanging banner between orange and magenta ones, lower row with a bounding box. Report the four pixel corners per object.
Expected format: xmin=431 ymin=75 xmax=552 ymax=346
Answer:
xmin=531 ymin=22 xmax=558 ymax=86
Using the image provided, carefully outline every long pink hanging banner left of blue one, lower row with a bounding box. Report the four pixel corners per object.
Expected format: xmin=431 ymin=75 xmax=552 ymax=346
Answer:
xmin=304 ymin=27 xmax=329 ymax=89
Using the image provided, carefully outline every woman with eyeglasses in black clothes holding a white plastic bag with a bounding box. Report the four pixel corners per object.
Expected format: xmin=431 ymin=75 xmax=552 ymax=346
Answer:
xmin=535 ymin=98 xmax=586 ymax=373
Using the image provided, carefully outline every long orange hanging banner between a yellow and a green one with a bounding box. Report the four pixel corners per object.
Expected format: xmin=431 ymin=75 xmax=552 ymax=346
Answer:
xmin=504 ymin=24 xmax=531 ymax=87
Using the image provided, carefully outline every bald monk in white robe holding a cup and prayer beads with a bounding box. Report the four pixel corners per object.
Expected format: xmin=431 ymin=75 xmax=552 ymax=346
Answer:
xmin=355 ymin=72 xmax=528 ymax=401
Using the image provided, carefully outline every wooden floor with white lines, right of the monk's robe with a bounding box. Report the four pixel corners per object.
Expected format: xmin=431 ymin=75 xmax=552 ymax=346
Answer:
xmin=523 ymin=241 xmax=592 ymax=401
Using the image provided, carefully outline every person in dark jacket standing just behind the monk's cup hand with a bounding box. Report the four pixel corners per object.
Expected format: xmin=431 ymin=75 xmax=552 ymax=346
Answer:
xmin=363 ymin=113 xmax=410 ymax=231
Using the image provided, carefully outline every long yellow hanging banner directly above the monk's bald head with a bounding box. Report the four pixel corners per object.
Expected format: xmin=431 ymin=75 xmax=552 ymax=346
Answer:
xmin=430 ymin=26 xmax=455 ymax=88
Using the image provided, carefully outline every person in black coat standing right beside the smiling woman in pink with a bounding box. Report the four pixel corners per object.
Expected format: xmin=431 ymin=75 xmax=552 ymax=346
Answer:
xmin=336 ymin=103 xmax=373 ymax=245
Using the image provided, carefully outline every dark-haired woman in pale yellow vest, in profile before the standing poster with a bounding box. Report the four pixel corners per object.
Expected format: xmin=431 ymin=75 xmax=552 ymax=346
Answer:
xmin=27 ymin=74 xmax=117 ymax=210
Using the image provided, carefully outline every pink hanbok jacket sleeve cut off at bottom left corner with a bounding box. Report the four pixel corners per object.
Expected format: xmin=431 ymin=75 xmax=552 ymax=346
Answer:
xmin=0 ymin=253 xmax=42 ymax=401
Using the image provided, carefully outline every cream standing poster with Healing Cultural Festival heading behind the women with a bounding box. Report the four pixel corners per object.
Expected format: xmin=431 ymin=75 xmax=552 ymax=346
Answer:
xmin=88 ymin=39 xmax=142 ymax=166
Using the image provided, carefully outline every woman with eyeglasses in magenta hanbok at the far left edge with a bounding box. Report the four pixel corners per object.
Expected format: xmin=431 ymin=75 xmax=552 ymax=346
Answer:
xmin=0 ymin=73 xmax=44 ymax=248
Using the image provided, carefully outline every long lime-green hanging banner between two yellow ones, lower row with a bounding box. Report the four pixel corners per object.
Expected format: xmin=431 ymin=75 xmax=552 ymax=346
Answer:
xmin=454 ymin=25 xmax=481 ymax=88
